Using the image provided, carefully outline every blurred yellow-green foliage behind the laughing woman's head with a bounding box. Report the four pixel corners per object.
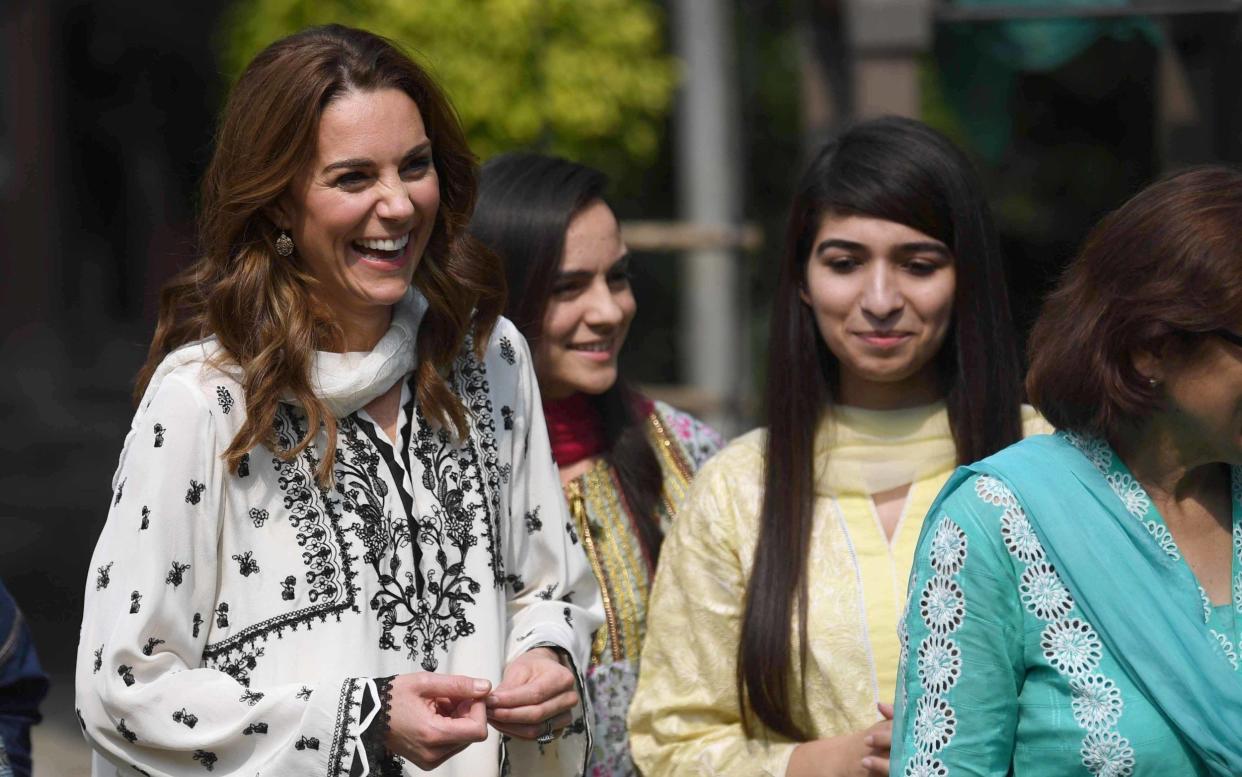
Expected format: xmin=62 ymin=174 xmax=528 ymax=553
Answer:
xmin=217 ymin=0 xmax=677 ymax=177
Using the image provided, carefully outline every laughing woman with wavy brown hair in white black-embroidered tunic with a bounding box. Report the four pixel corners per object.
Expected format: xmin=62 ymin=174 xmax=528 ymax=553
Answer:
xmin=77 ymin=26 xmax=601 ymax=777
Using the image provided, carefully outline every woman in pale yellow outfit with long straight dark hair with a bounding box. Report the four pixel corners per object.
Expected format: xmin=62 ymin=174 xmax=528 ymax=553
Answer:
xmin=630 ymin=118 xmax=1051 ymax=777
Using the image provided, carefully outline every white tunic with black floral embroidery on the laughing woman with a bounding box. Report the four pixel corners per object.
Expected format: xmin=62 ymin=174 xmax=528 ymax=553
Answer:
xmin=77 ymin=293 xmax=602 ymax=777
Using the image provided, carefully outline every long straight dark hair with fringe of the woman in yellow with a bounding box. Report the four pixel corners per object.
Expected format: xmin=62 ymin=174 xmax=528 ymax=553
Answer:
xmin=737 ymin=117 xmax=1022 ymax=740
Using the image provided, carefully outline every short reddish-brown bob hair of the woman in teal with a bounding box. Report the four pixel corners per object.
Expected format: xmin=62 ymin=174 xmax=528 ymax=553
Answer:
xmin=1026 ymin=165 xmax=1242 ymax=439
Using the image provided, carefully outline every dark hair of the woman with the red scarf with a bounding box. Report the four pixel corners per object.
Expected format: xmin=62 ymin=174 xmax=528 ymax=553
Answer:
xmin=469 ymin=153 xmax=663 ymax=565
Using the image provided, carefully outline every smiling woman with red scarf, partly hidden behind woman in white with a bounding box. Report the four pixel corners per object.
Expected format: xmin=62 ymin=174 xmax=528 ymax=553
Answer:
xmin=471 ymin=154 xmax=722 ymax=777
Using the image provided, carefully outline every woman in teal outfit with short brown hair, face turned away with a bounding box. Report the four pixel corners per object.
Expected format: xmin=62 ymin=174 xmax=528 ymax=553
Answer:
xmin=892 ymin=168 xmax=1242 ymax=777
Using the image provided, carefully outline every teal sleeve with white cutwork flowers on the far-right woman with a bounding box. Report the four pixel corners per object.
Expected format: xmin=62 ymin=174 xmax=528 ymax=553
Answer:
xmin=891 ymin=477 xmax=1037 ymax=777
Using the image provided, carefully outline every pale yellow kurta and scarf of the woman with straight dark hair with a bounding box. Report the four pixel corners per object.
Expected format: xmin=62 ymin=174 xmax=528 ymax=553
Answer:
xmin=630 ymin=405 xmax=1051 ymax=777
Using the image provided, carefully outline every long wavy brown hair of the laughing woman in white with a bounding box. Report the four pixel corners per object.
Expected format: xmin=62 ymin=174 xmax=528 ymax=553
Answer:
xmin=134 ymin=25 xmax=504 ymax=484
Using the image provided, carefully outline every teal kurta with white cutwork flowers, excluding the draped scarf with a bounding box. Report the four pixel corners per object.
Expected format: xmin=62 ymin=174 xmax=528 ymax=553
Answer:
xmin=891 ymin=436 xmax=1242 ymax=777
